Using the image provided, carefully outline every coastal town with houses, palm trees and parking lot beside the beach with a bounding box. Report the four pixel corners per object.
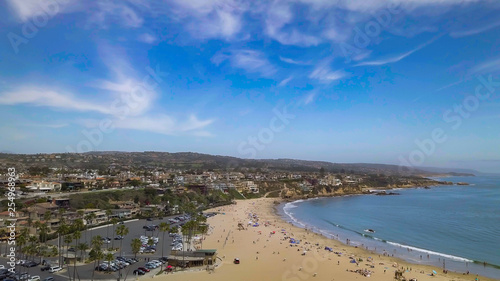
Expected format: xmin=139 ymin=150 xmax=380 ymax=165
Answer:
xmin=0 ymin=151 xmax=478 ymax=280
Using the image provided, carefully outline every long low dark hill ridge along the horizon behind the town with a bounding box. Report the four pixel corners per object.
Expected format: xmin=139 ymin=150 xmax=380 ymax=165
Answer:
xmin=0 ymin=151 xmax=473 ymax=176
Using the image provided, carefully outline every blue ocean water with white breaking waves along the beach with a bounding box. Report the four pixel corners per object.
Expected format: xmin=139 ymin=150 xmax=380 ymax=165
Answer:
xmin=282 ymin=176 xmax=500 ymax=279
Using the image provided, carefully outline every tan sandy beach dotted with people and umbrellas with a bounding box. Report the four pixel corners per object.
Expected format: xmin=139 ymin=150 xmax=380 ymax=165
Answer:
xmin=155 ymin=198 xmax=494 ymax=281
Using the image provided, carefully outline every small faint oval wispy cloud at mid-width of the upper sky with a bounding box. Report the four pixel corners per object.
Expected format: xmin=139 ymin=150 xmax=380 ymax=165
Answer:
xmin=211 ymin=50 xmax=277 ymax=77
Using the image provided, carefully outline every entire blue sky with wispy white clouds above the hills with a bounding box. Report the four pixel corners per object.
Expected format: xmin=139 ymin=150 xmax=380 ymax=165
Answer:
xmin=0 ymin=0 xmax=500 ymax=172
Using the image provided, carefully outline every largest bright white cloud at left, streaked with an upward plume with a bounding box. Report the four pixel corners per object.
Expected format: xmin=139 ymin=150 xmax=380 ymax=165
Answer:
xmin=0 ymin=46 xmax=214 ymax=136
